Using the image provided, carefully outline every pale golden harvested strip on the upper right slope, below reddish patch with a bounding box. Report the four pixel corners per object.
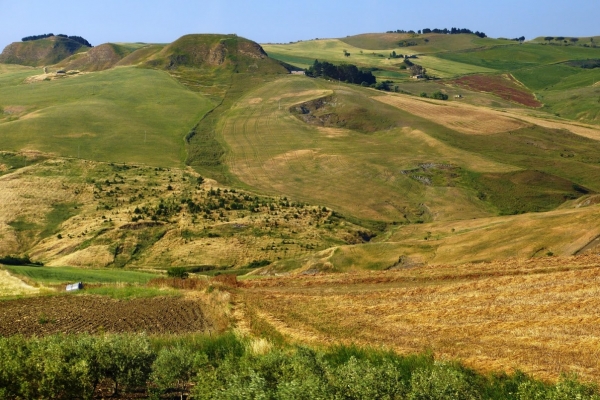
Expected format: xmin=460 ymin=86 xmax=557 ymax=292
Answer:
xmin=373 ymin=95 xmax=526 ymax=135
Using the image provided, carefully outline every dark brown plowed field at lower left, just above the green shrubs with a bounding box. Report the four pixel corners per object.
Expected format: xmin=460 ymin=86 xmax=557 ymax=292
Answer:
xmin=0 ymin=295 xmax=213 ymax=336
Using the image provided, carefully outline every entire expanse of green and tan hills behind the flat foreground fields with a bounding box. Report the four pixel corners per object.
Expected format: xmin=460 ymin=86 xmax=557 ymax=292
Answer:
xmin=0 ymin=34 xmax=600 ymax=272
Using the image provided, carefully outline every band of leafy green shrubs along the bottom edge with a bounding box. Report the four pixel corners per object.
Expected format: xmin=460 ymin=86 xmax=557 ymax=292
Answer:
xmin=0 ymin=333 xmax=600 ymax=400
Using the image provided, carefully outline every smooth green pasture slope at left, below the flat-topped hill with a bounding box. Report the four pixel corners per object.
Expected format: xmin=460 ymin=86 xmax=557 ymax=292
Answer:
xmin=0 ymin=67 xmax=213 ymax=166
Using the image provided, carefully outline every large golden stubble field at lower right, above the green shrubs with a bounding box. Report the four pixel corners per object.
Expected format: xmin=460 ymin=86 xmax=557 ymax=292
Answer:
xmin=241 ymin=255 xmax=600 ymax=382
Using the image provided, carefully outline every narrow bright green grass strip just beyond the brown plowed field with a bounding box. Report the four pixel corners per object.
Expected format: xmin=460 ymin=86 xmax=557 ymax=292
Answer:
xmin=4 ymin=265 xmax=160 ymax=285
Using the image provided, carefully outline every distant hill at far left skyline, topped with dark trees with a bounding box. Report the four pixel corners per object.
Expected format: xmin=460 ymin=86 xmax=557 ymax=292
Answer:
xmin=0 ymin=36 xmax=89 ymax=67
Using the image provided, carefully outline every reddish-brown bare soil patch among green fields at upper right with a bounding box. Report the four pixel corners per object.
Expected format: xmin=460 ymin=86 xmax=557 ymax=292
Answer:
xmin=449 ymin=75 xmax=542 ymax=107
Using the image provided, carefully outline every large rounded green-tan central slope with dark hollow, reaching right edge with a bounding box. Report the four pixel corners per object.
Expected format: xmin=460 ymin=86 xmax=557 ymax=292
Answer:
xmin=217 ymin=73 xmax=600 ymax=222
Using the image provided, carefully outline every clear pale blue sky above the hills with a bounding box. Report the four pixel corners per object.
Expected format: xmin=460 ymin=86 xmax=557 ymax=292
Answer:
xmin=0 ymin=0 xmax=600 ymax=49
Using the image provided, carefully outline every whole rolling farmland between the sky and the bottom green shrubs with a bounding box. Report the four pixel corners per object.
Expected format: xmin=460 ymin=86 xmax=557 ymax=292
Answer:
xmin=0 ymin=29 xmax=600 ymax=398
